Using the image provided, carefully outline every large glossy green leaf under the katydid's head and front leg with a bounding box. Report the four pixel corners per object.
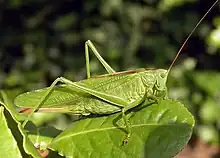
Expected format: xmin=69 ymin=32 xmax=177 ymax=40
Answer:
xmin=49 ymin=100 xmax=195 ymax=158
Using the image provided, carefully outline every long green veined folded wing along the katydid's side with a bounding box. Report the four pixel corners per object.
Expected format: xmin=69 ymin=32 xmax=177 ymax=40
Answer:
xmin=15 ymin=73 xmax=145 ymax=114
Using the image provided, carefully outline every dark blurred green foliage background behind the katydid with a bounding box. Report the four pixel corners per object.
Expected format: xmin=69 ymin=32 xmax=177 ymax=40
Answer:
xmin=0 ymin=0 xmax=220 ymax=144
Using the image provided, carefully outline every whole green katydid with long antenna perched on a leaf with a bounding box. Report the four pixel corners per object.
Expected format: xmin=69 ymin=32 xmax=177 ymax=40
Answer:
xmin=15 ymin=0 xmax=218 ymax=143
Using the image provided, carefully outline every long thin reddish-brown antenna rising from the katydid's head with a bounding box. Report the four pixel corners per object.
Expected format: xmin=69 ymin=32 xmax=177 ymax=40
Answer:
xmin=168 ymin=0 xmax=218 ymax=73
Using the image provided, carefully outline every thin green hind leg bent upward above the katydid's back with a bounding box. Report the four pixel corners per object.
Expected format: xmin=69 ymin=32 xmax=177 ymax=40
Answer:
xmin=85 ymin=40 xmax=115 ymax=78
